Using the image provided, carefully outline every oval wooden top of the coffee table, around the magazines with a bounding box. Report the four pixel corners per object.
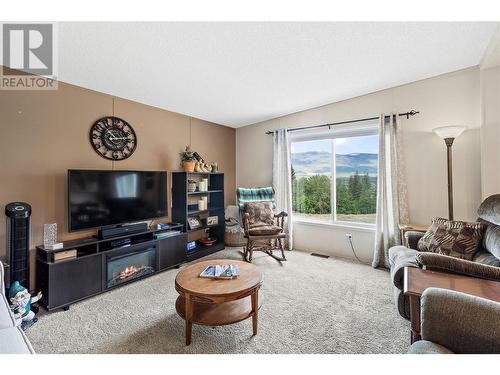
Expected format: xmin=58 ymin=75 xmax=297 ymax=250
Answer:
xmin=175 ymin=259 xmax=262 ymax=298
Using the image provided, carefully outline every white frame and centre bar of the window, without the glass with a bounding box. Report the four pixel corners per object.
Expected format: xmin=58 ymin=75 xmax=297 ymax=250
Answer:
xmin=290 ymin=120 xmax=380 ymax=231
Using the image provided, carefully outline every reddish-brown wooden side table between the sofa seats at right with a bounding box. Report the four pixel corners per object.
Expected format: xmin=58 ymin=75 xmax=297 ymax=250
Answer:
xmin=404 ymin=267 xmax=500 ymax=344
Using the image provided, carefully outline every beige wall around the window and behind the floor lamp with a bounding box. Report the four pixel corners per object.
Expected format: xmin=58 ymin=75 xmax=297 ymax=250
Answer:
xmin=236 ymin=67 xmax=481 ymax=261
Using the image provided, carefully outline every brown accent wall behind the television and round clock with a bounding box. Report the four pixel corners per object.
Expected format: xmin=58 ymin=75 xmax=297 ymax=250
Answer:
xmin=0 ymin=78 xmax=236 ymax=287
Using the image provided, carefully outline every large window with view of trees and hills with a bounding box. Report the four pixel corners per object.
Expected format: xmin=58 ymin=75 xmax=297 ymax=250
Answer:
xmin=291 ymin=123 xmax=378 ymax=225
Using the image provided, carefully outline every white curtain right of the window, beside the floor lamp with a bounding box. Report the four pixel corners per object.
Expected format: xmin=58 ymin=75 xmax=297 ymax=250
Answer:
xmin=372 ymin=114 xmax=408 ymax=268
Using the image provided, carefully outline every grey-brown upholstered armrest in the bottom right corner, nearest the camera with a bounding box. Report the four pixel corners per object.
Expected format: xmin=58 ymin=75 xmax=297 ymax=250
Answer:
xmin=420 ymin=288 xmax=500 ymax=354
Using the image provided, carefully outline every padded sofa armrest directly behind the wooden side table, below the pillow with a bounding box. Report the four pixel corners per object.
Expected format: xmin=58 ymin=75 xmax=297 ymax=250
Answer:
xmin=416 ymin=252 xmax=500 ymax=281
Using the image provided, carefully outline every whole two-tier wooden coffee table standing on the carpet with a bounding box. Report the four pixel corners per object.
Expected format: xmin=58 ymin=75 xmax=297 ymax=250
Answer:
xmin=175 ymin=259 xmax=262 ymax=345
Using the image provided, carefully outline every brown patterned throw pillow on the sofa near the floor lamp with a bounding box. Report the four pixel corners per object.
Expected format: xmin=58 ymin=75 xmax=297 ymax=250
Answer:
xmin=417 ymin=217 xmax=484 ymax=260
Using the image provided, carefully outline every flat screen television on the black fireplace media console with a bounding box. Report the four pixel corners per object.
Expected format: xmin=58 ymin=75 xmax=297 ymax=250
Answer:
xmin=68 ymin=169 xmax=168 ymax=232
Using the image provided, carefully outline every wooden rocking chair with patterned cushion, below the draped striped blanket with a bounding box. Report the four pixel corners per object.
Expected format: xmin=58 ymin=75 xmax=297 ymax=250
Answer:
xmin=243 ymin=202 xmax=288 ymax=262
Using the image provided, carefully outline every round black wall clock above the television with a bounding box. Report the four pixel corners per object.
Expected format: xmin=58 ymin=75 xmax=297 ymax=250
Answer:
xmin=89 ymin=116 xmax=137 ymax=160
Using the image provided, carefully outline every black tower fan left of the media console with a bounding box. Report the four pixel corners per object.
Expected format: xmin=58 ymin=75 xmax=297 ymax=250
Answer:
xmin=5 ymin=202 xmax=31 ymax=290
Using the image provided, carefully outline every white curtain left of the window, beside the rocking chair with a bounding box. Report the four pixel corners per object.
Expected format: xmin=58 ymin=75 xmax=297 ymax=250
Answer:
xmin=273 ymin=129 xmax=293 ymax=250
